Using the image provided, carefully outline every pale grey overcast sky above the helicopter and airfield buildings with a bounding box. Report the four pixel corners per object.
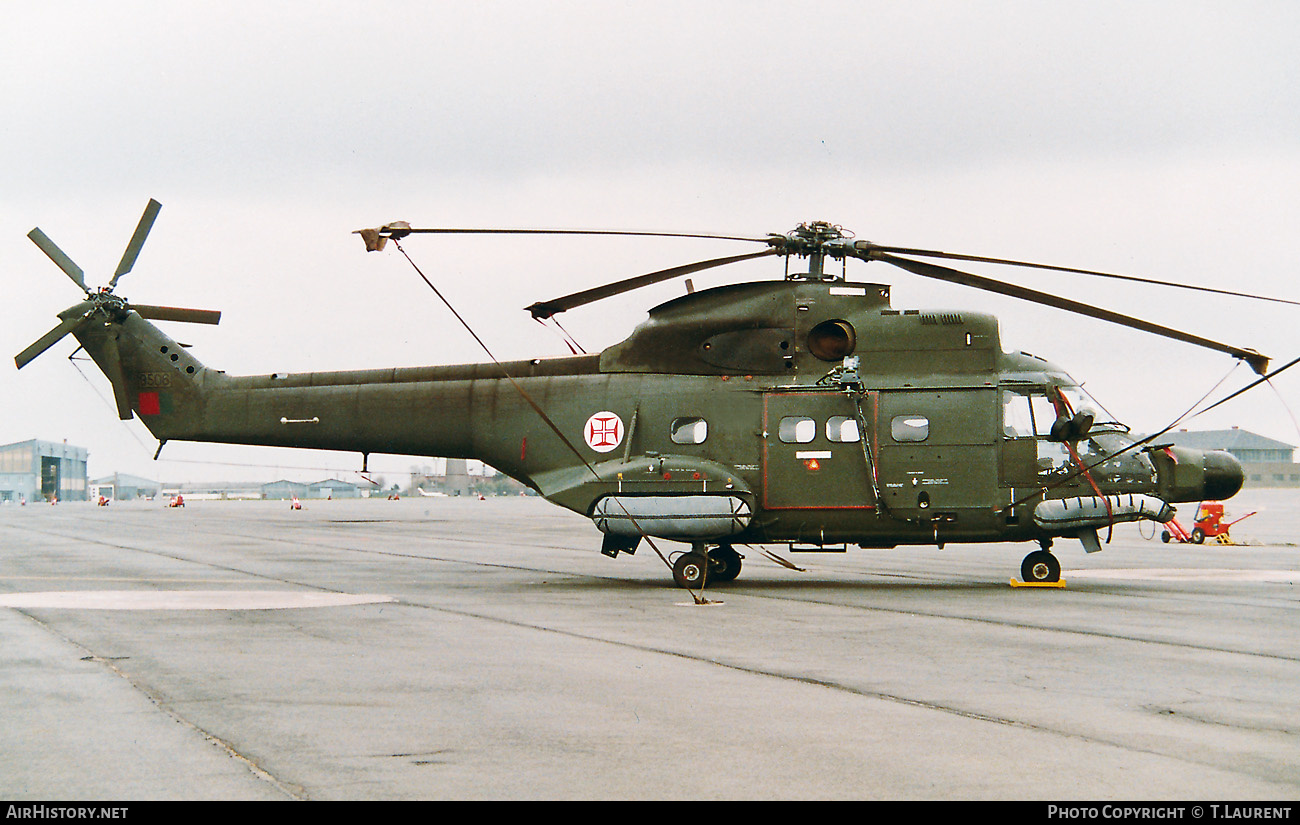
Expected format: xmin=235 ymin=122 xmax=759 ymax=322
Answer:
xmin=0 ymin=0 xmax=1300 ymax=481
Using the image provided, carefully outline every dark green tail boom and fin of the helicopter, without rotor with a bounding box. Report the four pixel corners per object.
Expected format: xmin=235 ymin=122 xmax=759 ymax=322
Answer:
xmin=74 ymin=313 xmax=599 ymax=483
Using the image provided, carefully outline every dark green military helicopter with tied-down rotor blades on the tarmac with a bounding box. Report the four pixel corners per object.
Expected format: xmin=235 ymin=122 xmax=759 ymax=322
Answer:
xmin=14 ymin=200 xmax=1296 ymax=589
